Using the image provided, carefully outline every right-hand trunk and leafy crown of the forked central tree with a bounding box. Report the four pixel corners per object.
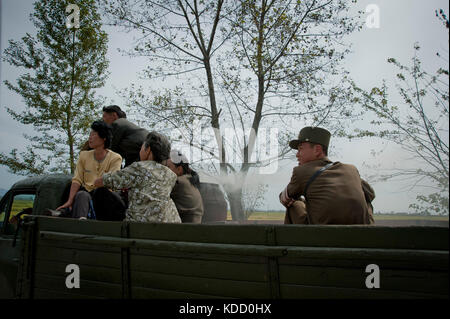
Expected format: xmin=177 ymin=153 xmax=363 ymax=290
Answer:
xmin=211 ymin=0 xmax=359 ymax=220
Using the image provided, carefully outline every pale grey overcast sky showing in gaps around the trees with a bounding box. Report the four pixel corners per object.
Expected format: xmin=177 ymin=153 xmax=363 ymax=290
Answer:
xmin=0 ymin=0 xmax=449 ymax=212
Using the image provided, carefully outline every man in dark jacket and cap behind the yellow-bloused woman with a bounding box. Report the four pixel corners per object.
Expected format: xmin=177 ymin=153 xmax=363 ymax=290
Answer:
xmin=103 ymin=105 xmax=149 ymax=167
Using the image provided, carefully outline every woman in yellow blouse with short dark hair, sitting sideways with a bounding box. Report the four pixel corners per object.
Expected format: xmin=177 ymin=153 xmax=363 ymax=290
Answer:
xmin=56 ymin=121 xmax=126 ymax=220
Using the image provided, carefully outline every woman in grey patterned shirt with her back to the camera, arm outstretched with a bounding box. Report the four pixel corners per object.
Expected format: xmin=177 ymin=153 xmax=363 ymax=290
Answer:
xmin=95 ymin=132 xmax=181 ymax=223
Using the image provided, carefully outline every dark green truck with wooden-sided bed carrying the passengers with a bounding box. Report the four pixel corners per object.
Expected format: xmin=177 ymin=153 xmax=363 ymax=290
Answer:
xmin=0 ymin=175 xmax=449 ymax=299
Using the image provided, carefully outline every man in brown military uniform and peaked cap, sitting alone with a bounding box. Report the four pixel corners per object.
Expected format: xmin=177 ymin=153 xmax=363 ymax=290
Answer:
xmin=280 ymin=127 xmax=375 ymax=225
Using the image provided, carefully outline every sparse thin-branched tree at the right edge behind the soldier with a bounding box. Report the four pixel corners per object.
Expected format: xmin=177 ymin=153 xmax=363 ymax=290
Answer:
xmin=355 ymin=10 xmax=449 ymax=215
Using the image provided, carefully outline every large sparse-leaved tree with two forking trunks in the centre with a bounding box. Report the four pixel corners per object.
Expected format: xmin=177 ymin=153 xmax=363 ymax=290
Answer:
xmin=105 ymin=0 xmax=359 ymax=220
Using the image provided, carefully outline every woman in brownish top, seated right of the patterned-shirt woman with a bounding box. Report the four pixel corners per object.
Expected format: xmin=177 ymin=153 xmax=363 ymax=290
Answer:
xmin=168 ymin=150 xmax=203 ymax=224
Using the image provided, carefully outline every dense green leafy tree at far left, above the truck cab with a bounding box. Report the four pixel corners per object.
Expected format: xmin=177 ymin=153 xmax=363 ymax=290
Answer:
xmin=0 ymin=0 xmax=108 ymax=175
